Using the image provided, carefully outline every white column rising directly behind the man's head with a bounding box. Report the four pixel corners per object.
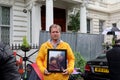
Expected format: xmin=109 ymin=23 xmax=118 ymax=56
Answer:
xmin=46 ymin=0 xmax=53 ymax=31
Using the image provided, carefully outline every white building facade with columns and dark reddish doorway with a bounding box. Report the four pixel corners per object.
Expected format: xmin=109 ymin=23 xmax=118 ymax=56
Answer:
xmin=0 ymin=0 xmax=120 ymax=44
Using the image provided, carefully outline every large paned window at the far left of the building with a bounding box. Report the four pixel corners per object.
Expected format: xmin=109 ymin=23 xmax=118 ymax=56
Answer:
xmin=0 ymin=6 xmax=10 ymax=44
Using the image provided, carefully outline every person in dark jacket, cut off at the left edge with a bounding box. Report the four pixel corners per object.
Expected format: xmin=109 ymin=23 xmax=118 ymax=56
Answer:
xmin=0 ymin=42 xmax=21 ymax=80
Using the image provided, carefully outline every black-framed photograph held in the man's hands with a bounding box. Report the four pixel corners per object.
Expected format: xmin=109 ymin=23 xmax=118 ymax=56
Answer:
xmin=47 ymin=49 xmax=67 ymax=72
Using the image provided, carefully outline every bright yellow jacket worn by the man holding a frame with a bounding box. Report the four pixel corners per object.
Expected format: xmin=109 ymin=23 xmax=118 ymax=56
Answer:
xmin=36 ymin=41 xmax=75 ymax=80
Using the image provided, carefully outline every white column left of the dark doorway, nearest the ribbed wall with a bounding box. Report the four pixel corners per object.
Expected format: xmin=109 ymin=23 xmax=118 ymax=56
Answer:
xmin=32 ymin=3 xmax=41 ymax=44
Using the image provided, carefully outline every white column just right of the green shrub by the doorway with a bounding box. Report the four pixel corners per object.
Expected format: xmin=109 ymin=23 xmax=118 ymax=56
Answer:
xmin=80 ymin=2 xmax=87 ymax=33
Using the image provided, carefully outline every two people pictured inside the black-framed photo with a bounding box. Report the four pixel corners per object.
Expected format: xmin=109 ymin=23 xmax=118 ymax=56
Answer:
xmin=48 ymin=50 xmax=66 ymax=72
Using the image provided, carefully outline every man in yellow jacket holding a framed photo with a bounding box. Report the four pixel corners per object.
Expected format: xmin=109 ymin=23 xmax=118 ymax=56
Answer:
xmin=36 ymin=24 xmax=75 ymax=80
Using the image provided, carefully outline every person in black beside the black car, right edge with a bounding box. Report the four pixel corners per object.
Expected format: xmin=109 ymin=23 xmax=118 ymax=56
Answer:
xmin=106 ymin=39 xmax=120 ymax=80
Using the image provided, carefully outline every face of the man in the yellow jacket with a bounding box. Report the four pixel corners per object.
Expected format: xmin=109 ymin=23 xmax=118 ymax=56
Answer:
xmin=50 ymin=28 xmax=60 ymax=40
